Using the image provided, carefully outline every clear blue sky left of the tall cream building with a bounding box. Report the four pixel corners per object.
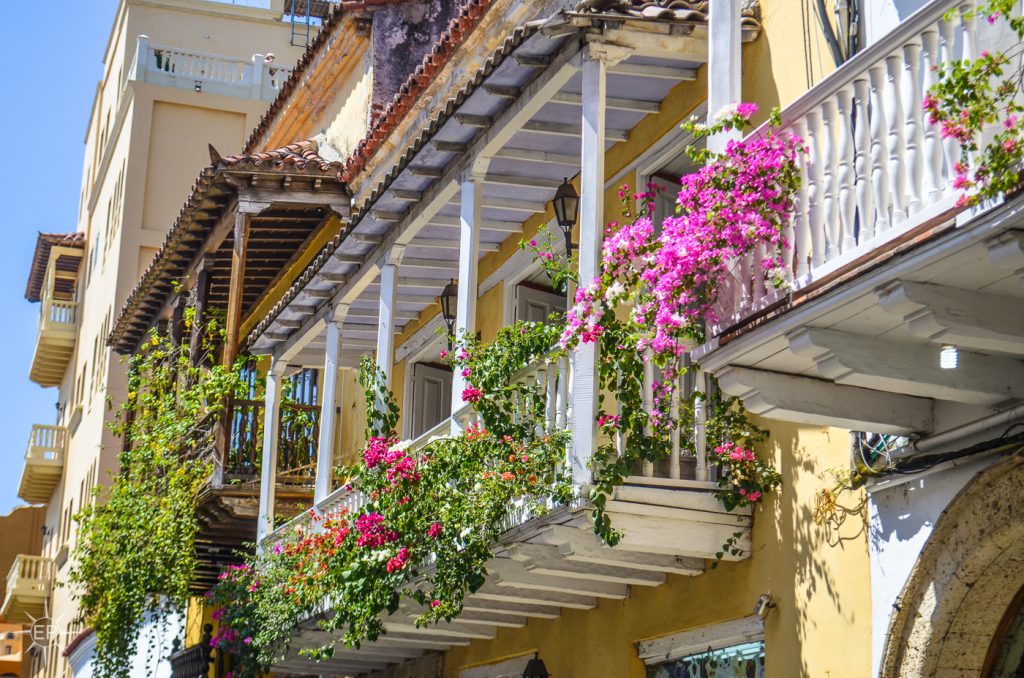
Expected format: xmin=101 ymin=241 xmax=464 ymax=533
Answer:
xmin=0 ymin=0 xmax=117 ymax=514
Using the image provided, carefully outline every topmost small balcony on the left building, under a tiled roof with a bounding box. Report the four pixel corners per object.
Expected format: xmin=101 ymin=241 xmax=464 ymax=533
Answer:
xmin=29 ymin=247 xmax=82 ymax=386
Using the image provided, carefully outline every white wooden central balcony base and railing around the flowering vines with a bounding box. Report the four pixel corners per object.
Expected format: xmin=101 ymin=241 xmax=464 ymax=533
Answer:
xmin=265 ymin=358 xmax=752 ymax=674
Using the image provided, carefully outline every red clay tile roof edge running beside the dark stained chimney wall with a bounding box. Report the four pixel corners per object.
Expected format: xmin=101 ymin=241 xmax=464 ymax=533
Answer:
xmin=342 ymin=0 xmax=493 ymax=182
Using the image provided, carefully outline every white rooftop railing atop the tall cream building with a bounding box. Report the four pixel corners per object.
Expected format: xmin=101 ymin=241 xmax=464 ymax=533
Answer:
xmin=131 ymin=36 xmax=292 ymax=101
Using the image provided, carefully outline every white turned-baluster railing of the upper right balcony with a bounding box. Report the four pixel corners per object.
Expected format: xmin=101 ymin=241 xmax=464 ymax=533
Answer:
xmin=711 ymin=0 xmax=978 ymax=335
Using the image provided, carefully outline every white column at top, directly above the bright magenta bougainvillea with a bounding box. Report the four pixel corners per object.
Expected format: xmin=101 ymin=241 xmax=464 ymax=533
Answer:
xmin=708 ymin=0 xmax=742 ymax=153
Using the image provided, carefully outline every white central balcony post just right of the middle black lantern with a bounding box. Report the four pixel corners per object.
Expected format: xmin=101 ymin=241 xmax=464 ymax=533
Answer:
xmin=452 ymin=172 xmax=483 ymax=414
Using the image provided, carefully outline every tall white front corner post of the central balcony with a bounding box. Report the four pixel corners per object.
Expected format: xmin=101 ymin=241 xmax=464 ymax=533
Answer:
xmin=570 ymin=55 xmax=607 ymax=484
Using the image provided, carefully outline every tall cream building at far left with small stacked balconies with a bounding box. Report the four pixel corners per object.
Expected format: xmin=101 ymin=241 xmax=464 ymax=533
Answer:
xmin=12 ymin=0 xmax=309 ymax=678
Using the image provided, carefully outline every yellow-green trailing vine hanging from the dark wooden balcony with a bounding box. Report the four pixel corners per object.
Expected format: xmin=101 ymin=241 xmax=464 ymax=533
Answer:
xmin=70 ymin=317 xmax=250 ymax=678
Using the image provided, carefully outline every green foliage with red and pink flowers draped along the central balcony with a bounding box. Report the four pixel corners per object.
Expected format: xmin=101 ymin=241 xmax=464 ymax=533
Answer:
xmin=208 ymin=337 xmax=570 ymax=676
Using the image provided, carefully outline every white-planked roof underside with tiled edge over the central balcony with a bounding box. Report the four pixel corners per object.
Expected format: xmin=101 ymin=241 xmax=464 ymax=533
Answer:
xmin=246 ymin=5 xmax=757 ymax=353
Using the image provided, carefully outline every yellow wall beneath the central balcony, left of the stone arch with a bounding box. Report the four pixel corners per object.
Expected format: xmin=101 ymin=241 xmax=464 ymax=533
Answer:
xmin=444 ymin=422 xmax=870 ymax=678
